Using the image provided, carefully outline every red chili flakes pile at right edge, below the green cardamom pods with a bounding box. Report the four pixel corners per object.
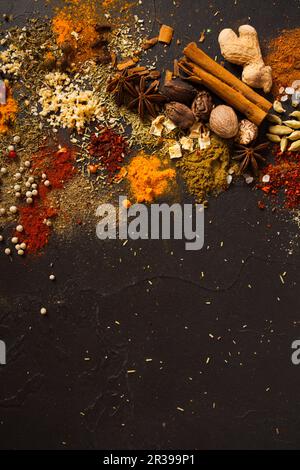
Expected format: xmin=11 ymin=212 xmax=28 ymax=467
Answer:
xmin=261 ymin=152 xmax=300 ymax=209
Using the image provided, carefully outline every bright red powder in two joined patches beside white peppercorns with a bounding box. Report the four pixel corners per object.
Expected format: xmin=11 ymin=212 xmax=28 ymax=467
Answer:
xmin=16 ymin=148 xmax=76 ymax=254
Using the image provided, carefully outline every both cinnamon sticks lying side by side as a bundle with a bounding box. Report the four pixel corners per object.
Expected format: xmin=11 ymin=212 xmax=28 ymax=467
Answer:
xmin=178 ymin=43 xmax=272 ymax=126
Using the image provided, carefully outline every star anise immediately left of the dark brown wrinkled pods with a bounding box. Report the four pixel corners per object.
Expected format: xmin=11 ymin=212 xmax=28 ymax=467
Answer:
xmin=128 ymin=76 xmax=166 ymax=119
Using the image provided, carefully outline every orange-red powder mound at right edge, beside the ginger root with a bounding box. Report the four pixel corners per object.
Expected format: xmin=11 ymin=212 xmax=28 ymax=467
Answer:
xmin=265 ymin=28 xmax=300 ymax=94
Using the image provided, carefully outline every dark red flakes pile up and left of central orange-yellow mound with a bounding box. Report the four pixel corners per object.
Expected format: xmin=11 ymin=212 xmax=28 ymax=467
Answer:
xmin=89 ymin=128 xmax=128 ymax=178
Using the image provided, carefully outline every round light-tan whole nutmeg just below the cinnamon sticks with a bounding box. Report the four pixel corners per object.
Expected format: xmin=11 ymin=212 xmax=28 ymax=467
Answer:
xmin=209 ymin=105 xmax=239 ymax=139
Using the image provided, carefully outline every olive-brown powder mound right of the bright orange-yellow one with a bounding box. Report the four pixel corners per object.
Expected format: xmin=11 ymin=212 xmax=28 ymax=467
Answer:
xmin=177 ymin=137 xmax=230 ymax=203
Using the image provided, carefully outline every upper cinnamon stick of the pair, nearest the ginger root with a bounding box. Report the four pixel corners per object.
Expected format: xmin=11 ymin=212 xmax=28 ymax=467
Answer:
xmin=184 ymin=42 xmax=272 ymax=112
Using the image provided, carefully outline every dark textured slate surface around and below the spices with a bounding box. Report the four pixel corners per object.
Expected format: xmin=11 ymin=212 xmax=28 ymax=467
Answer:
xmin=0 ymin=0 xmax=300 ymax=449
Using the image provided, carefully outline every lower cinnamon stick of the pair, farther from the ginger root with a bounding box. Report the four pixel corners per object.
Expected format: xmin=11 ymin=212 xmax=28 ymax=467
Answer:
xmin=179 ymin=59 xmax=267 ymax=126
